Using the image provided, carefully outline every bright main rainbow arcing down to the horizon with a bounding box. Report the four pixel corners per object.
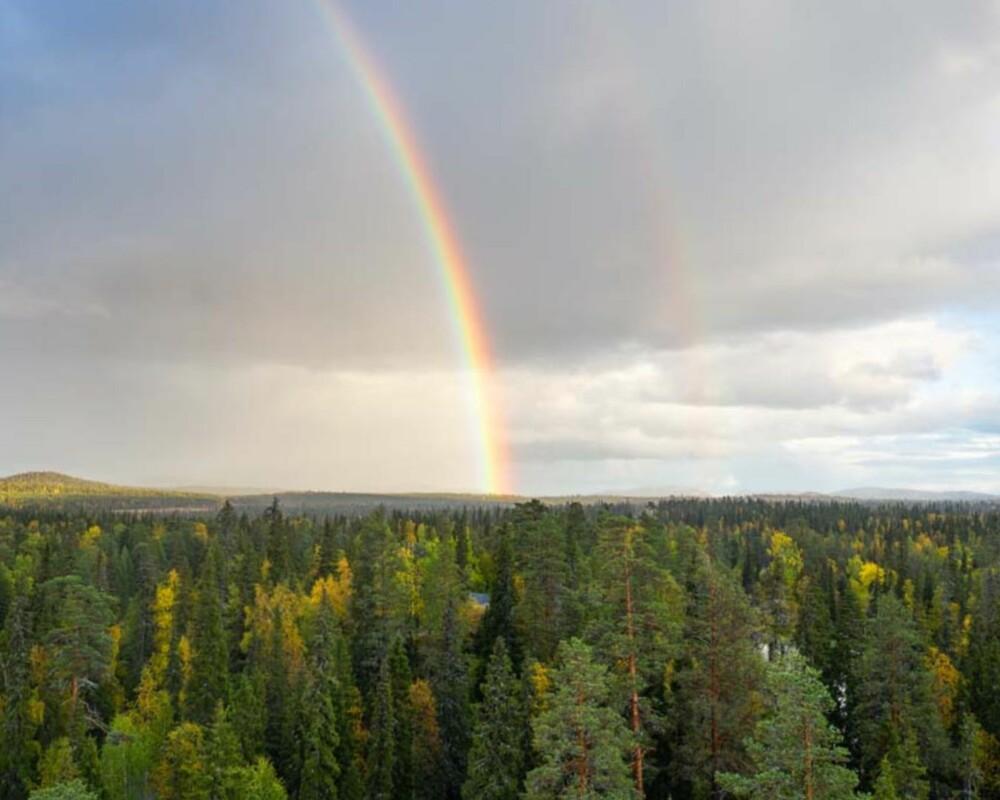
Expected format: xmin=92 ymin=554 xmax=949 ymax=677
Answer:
xmin=316 ymin=0 xmax=511 ymax=494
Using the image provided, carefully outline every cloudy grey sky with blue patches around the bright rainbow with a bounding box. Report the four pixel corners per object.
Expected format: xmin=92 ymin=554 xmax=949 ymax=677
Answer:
xmin=0 ymin=0 xmax=1000 ymax=494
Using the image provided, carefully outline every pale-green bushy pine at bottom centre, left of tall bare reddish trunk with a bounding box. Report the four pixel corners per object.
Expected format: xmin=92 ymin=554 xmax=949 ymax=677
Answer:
xmin=525 ymin=639 xmax=636 ymax=800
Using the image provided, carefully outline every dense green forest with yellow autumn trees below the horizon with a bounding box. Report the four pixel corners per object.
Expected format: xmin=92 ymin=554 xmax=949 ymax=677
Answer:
xmin=0 ymin=499 xmax=1000 ymax=800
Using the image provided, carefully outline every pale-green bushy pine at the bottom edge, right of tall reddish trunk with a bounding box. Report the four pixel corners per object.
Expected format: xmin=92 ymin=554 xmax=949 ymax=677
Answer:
xmin=717 ymin=650 xmax=858 ymax=800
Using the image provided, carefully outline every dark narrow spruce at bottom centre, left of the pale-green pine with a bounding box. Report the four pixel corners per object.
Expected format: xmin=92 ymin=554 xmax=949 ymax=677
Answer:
xmin=462 ymin=637 xmax=527 ymax=800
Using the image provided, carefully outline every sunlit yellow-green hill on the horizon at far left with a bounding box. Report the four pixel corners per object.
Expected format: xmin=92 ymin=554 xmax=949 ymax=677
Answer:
xmin=0 ymin=472 xmax=219 ymax=510
